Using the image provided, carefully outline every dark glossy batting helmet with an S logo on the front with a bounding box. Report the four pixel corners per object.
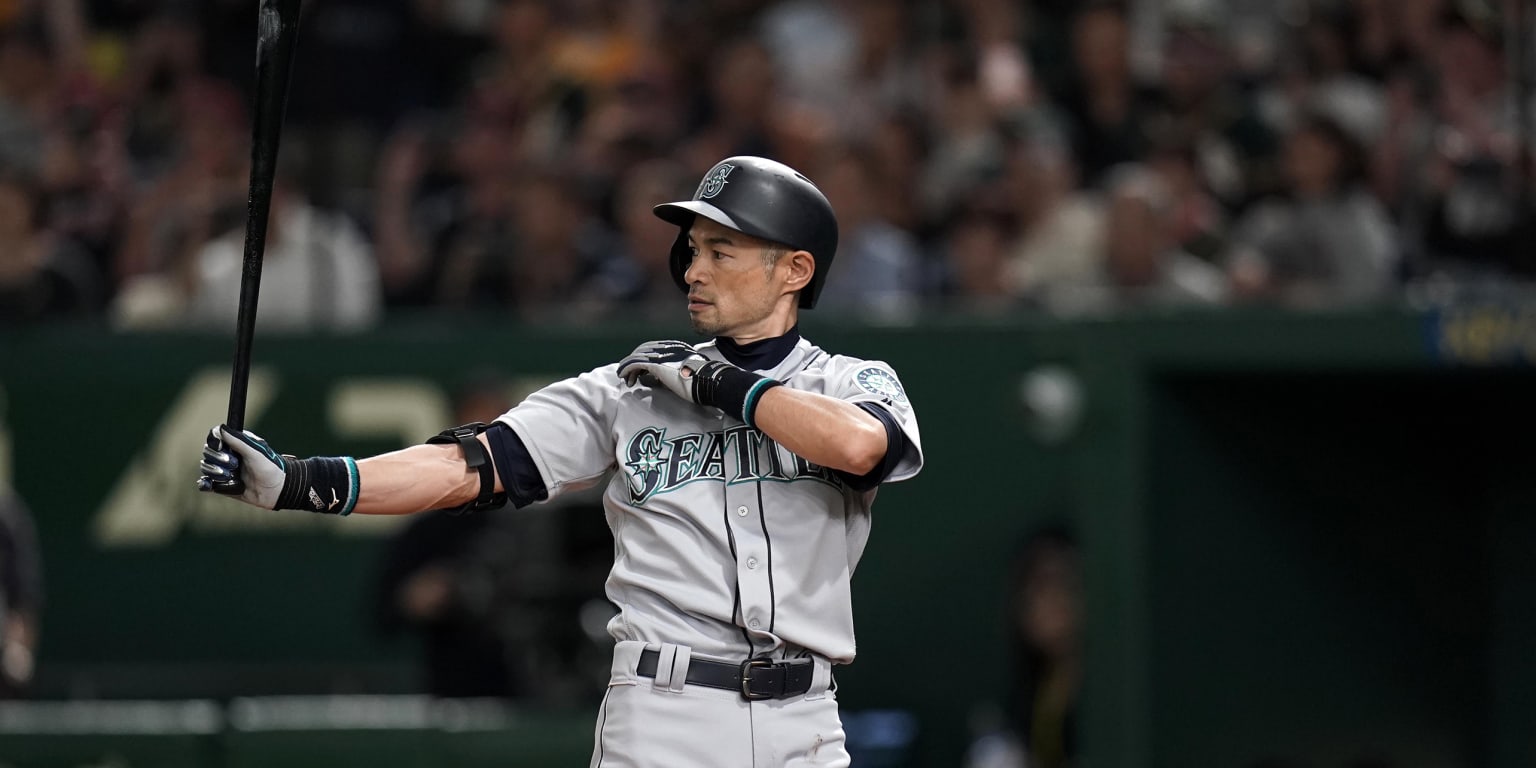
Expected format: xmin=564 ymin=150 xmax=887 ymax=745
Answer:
xmin=654 ymin=155 xmax=837 ymax=309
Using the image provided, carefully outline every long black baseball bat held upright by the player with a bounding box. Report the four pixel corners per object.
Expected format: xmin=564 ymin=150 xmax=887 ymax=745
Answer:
xmin=224 ymin=0 xmax=300 ymax=432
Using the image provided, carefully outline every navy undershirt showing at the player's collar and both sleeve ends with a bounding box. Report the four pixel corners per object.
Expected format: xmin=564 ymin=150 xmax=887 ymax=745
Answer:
xmin=485 ymin=326 xmax=906 ymax=507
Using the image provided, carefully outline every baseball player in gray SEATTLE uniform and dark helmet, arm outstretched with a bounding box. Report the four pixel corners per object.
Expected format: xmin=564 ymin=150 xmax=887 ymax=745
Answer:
xmin=198 ymin=157 xmax=923 ymax=768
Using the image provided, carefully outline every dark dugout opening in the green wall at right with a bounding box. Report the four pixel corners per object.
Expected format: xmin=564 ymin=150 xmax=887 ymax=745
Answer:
xmin=1144 ymin=370 xmax=1536 ymax=768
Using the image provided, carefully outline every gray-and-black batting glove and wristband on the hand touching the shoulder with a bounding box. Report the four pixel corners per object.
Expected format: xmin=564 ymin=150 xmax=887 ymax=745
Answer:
xmin=619 ymin=341 xmax=779 ymax=425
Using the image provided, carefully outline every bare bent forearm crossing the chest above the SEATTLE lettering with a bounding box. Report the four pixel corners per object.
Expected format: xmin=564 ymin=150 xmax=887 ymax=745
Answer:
xmin=753 ymin=387 xmax=888 ymax=475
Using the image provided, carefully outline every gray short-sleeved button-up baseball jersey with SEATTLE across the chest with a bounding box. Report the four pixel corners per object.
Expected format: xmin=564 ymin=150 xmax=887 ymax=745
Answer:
xmin=498 ymin=338 xmax=923 ymax=664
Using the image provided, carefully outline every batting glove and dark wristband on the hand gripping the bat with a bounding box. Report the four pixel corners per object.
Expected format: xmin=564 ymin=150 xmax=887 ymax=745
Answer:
xmin=197 ymin=425 xmax=358 ymax=515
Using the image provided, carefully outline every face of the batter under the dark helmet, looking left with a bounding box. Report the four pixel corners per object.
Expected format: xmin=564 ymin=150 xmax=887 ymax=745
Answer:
xmin=684 ymin=217 xmax=788 ymax=338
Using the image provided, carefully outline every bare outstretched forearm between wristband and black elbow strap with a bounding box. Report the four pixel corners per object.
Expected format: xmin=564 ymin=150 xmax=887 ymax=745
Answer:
xmin=352 ymin=444 xmax=479 ymax=515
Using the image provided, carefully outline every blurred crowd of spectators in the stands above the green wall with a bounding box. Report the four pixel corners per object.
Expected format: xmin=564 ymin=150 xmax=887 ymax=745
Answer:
xmin=0 ymin=0 xmax=1536 ymax=330
